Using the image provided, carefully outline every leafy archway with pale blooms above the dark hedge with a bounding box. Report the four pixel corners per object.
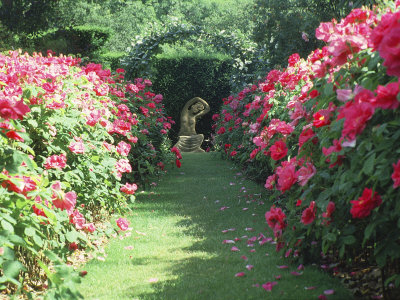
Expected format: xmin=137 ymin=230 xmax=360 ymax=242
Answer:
xmin=122 ymin=24 xmax=260 ymax=88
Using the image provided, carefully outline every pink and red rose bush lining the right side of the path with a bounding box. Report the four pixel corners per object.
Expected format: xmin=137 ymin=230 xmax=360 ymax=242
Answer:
xmin=213 ymin=1 xmax=400 ymax=285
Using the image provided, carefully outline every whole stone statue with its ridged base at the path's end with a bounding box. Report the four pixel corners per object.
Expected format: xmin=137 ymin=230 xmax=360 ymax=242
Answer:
xmin=175 ymin=97 xmax=210 ymax=152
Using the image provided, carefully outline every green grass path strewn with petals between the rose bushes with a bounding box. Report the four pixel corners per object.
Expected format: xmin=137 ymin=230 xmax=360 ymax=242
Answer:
xmin=80 ymin=153 xmax=351 ymax=300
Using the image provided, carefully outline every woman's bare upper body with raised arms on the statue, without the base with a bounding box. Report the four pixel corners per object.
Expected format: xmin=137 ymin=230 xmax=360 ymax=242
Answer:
xmin=178 ymin=97 xmax=210 ymax=136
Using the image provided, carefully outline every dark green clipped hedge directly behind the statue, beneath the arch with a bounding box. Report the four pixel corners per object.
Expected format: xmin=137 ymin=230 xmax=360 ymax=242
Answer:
xmin=152 ymin=56 xmax=232 ymax=148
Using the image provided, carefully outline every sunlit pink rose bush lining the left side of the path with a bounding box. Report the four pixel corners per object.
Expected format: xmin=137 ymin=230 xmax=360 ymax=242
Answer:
xmin=0 ymin=51 xmax=175 ymax=298
